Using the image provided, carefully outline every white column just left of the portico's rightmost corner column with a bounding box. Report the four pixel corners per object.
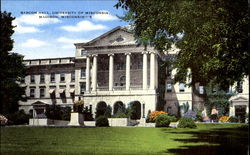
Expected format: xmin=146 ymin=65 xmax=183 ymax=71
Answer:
xmin=142 ymin=51 xmax=148 ymax=89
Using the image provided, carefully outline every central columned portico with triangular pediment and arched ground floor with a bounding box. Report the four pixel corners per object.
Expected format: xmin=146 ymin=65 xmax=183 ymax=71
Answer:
xmin=75 ymin=27 xmax=157 ymax=118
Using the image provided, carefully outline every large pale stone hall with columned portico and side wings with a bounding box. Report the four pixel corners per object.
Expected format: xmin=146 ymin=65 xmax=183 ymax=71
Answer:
xmin=20 ymin=27 xmax=249 ymax=119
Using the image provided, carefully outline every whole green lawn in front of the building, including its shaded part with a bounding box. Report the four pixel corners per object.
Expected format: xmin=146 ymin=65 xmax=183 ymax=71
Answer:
xmin=1 ymin=124 xmax=248 ymax=155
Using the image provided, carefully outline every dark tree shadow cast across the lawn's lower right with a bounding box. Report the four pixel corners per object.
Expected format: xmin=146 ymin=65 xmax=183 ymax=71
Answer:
xmin=163 ymin=126 xmax=249 ymax=155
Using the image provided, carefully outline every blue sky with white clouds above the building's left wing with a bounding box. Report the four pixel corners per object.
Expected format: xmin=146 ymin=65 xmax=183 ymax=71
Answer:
xmin=1 ymin=0 xmax=128 ymax=59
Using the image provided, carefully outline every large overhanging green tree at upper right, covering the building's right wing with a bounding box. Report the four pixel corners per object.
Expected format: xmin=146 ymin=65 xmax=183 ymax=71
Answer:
xmin=116 ymin=0 xmax=250 ymax=90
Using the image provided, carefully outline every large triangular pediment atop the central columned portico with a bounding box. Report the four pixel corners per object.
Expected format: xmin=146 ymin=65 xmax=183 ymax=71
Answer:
xmin=77 ymin=27 xmax=136 ymax=47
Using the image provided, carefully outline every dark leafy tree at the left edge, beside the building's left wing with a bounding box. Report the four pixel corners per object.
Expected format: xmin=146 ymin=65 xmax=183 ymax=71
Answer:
xmin=0 ymin=12 xmax=25 ymax=114
